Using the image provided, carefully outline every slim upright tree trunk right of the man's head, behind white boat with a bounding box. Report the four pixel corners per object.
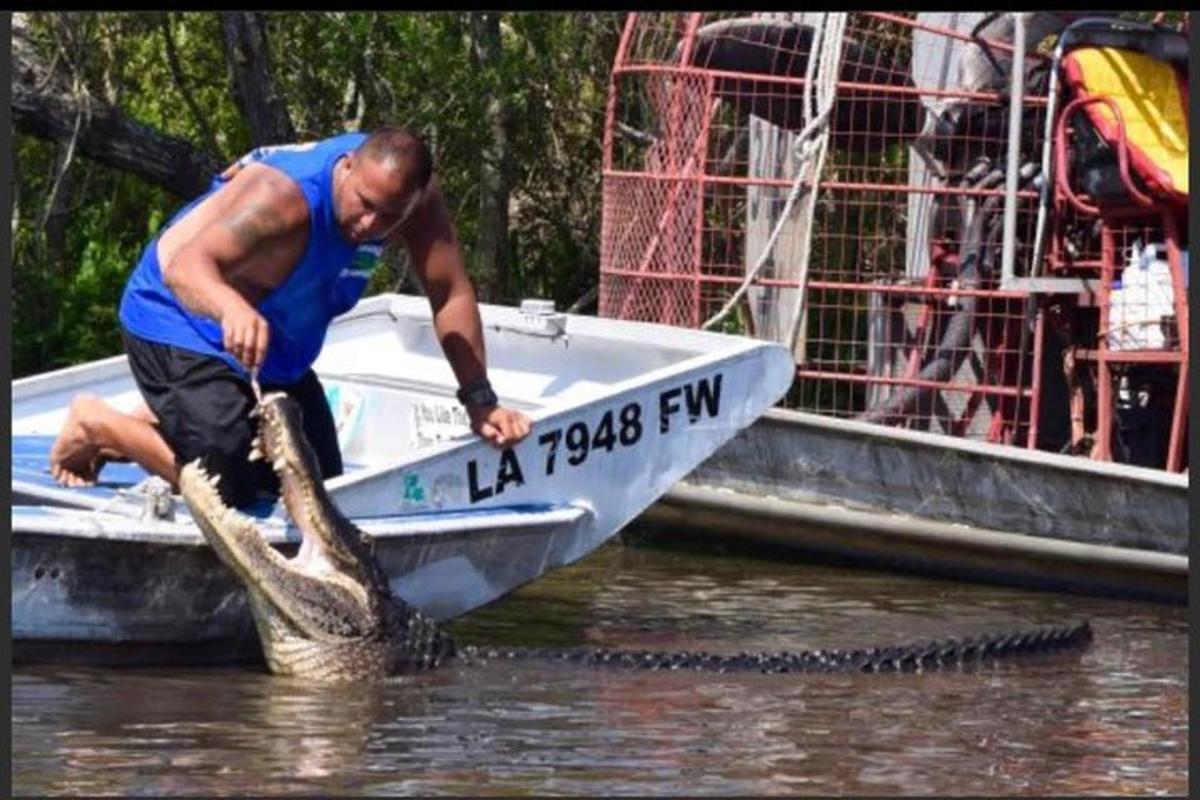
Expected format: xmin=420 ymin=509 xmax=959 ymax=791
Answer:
xmin=470 ymin=12 xmax=512 ymax=301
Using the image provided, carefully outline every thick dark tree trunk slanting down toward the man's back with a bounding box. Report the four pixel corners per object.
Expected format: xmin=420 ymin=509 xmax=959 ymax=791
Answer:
xmin=12 ymin=14 xmax=221 ymax=197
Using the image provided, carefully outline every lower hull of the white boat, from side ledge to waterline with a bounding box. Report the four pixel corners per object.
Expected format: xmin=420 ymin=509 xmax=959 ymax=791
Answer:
xmin=12 ymin=509 xmax=587 ymax=661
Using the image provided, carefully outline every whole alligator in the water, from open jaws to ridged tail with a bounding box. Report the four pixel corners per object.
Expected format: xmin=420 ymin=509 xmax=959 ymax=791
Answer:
xmin=180 ymin=393 xmax=1092 ymax=680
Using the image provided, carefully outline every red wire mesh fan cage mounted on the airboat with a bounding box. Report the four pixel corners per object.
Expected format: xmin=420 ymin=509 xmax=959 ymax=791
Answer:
xmin=600 ymin=12 xmax=1187 ymax=469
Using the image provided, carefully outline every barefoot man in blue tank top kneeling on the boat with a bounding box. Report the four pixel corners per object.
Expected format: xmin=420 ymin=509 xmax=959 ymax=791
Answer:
xmin=50 ymin=128 xmax=529 ymax=506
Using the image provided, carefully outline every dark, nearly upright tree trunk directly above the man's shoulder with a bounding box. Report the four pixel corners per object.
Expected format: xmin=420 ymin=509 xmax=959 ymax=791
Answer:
xmin=221 ymin=11 xmax=296 ymax=148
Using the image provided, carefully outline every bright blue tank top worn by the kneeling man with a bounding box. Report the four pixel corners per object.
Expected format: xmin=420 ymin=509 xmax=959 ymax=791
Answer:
xmin=119 ymin=133 xmax=383 ymax=384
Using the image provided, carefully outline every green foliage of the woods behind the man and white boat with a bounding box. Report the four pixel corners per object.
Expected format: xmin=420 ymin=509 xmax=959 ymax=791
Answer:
xmin=12 ymin=12 xmax=623 ymax=375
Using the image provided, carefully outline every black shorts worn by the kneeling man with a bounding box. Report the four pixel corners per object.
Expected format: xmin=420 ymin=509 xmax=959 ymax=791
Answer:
xmin=121 ymin=329 xmax=342 ymax=506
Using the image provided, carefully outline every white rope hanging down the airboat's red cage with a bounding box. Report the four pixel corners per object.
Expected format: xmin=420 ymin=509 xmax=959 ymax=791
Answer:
xmin=702 ymin=13 xmax=846 ymax=335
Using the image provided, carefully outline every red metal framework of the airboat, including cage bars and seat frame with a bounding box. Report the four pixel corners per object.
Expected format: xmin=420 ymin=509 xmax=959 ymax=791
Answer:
xmin=600 ymin=13 xmax=1188 ymax=470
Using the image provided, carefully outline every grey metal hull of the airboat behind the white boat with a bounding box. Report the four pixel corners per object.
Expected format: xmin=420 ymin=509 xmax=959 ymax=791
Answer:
xmin=641 ymin=409 xmax=1189 ymax=602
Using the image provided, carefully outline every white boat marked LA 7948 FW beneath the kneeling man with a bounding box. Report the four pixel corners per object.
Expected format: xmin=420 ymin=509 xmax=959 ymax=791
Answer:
xmin=12 ymin=295 xmax=793 ymax=658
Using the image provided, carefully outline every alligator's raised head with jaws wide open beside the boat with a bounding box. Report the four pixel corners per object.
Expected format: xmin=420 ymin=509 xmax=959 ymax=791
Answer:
xmin=180 ymin=393 xmax=454 ymax=679
